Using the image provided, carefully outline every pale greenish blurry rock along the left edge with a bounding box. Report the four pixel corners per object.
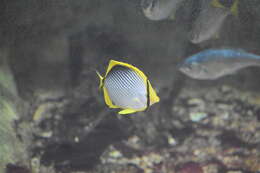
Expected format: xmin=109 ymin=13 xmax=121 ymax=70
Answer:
xmin=0 ymin=49 xmax=28 ymax=173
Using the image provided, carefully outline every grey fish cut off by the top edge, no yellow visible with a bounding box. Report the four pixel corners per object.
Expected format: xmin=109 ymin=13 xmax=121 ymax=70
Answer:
xmin=141 ymin=0 xmax=184 ymax=20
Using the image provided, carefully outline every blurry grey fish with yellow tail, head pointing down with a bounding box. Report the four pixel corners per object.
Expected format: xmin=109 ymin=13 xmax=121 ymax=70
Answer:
xmin=190 ymin=0 xmax=239 ymax=44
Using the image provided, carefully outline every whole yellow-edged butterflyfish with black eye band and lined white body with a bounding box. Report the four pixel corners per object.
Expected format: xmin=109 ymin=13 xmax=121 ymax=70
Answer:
xmin=97 ymin=60 xmax=160 ymax=114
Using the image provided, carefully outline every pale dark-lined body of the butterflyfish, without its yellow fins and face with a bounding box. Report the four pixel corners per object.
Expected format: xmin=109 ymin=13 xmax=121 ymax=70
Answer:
xmin=104 ymin=66 xmax=147 ymax=110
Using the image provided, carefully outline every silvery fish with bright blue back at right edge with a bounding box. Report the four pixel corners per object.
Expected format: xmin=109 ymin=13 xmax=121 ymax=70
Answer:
xmin=178 ymin=49 xmax=260 ymax=80
